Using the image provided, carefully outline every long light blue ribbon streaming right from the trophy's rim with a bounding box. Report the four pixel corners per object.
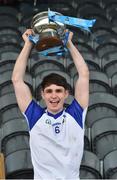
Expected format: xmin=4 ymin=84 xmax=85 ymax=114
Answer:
xmin=48 ymin=10 xmax=96 ymax=32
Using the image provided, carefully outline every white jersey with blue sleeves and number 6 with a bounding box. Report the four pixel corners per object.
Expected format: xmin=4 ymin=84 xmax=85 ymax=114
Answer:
xmin=24 ymin=99 xmax=87 ymax=180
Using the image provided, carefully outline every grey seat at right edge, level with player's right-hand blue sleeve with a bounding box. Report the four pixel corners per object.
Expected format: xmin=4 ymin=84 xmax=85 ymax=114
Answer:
xmin=86 ymin=92 xmax=117 ymax=127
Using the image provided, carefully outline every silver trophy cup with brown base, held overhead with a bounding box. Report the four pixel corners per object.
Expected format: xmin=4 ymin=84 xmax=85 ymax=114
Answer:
xmin=31 ymin=11 xmax=65 ymax=51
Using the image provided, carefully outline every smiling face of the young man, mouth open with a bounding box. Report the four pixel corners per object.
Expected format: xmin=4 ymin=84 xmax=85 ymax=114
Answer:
xmin=42 ymin=84 xmax=68 ymax=114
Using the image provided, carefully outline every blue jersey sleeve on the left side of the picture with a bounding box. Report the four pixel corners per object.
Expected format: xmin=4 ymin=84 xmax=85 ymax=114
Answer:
xmin=23 ymin=100 xmax=44 ymax=130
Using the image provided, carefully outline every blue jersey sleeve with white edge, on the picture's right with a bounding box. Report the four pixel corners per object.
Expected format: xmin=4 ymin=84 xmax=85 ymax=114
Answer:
xmin=66 ymin=99 xmax=87 ymax=128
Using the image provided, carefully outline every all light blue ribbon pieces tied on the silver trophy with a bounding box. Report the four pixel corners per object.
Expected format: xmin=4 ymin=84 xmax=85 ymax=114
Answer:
xmin=29 ymin=9 xmax=96 ymax=56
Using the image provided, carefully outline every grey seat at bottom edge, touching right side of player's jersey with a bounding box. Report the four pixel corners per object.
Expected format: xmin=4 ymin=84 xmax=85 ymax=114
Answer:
xmin=80 ymin=150 xmax=102 ymax=179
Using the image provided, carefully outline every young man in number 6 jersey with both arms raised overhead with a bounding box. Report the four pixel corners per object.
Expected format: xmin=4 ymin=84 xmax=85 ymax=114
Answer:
xmin=12 ymin=29 xmax=89 ymax=180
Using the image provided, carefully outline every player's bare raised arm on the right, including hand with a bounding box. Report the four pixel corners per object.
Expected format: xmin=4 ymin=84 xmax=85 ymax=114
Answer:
xmin=67 ymin=32 xmax=89 ymax=108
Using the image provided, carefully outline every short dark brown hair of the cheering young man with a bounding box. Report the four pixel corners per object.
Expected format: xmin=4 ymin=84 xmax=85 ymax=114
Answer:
xmin=41 ymin=73 xmax=69 ymax=90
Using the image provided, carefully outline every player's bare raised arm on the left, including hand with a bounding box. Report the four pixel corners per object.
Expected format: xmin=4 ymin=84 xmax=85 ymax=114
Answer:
xmin=12 ymin=29 xmax=33 ymax=112
